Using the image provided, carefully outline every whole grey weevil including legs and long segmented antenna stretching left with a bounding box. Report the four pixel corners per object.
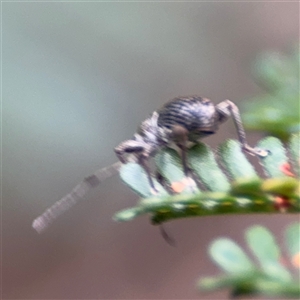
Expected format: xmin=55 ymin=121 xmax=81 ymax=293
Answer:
xmin=32 ymin=96 xmax=268 ymax=232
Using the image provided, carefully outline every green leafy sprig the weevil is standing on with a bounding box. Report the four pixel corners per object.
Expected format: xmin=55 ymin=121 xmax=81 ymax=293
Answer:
xmin=114 ymin=134 xmax=300 ymax=224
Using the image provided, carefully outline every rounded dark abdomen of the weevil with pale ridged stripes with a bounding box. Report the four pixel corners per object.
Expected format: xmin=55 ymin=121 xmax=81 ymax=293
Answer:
xmin=157 ymin=96 xmax=219 ymax=142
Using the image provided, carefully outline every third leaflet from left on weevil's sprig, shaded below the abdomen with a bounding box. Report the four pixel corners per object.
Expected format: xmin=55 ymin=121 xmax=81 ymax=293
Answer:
xmin=188 ymin=143 xmax=230 ymax=191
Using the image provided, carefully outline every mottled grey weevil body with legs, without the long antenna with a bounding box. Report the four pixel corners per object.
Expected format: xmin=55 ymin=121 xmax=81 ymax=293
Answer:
xmin=115 ymin=96 xmax=267 ymax=192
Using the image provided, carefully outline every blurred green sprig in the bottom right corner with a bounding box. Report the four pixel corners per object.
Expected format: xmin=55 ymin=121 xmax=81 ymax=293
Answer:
xmin=198 ymin=223 xmax=300 ymax=299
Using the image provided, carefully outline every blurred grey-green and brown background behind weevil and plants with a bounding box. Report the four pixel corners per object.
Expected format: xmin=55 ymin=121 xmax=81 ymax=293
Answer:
xmin=1 ymin=1 xmax=299 ymax=299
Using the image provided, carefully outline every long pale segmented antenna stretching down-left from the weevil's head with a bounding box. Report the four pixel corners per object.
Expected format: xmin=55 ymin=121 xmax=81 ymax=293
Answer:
xmin=32 ymin=162 xmax=122 ymax=233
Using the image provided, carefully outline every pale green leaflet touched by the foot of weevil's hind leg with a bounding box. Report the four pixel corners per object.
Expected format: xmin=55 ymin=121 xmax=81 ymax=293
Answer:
xmin=257 ymin=137 xmax=288 ymax=177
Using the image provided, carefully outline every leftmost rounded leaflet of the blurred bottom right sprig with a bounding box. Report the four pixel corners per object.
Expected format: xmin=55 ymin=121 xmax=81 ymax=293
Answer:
xmin=209 ymin=238 xmax=254 ymax=274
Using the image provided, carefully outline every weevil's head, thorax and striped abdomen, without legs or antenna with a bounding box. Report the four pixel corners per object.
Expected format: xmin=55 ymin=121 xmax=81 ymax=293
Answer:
xmin=115 ymin=96 xmax=221 ymax=162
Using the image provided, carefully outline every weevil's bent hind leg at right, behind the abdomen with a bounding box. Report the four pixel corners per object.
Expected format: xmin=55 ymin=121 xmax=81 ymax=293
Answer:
xmin=216 ymin=100 xmax=269 ymax=157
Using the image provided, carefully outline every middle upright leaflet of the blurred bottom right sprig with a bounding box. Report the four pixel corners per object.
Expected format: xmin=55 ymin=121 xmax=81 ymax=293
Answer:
xmin=246 ymin=226 xmax=291 ymax=281
